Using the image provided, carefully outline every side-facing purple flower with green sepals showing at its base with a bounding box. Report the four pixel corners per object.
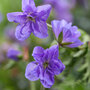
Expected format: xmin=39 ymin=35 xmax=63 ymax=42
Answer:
xmin=51 ymin=20 xmax=83 ymax=48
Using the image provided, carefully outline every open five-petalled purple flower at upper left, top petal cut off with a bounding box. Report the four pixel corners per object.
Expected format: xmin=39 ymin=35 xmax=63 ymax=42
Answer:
xmin=7 ymin=0 xmax=51 ymax=41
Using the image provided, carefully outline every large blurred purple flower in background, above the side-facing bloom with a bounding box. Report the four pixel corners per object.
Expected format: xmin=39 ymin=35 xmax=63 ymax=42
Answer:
xmin=44 ymin=0 xmax=76 ymax=22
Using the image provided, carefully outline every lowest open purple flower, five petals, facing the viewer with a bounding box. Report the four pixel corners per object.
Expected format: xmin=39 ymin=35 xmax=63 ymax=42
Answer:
xmin=25 ymin=45 xmax=65 ymax=88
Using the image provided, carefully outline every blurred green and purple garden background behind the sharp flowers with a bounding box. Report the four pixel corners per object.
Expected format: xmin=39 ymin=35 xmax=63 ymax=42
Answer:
xmin=0 ymin=0 xmax=90 ymax=90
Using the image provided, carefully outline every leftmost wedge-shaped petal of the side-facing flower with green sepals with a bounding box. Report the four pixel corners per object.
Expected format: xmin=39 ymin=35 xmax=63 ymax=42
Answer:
xmin=51 ymin=20 xmax=67 ymax=39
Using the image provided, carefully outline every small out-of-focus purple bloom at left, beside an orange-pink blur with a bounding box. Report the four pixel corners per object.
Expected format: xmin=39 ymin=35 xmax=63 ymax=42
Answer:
xmin=7 ymin=48 xmax=21 ymax=61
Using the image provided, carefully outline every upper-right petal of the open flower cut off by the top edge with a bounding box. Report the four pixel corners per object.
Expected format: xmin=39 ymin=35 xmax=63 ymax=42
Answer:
xmin=37 ymin=4 xmax=51 ymax=21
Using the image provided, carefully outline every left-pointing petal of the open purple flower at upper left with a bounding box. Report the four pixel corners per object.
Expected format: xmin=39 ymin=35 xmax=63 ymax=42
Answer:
xmin=7 ymin=12 xmax=26 ymax=23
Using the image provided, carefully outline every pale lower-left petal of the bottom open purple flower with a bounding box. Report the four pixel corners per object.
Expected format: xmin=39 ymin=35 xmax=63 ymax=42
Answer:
xmin=25 ymin=61 xmax=39 ymax=81
